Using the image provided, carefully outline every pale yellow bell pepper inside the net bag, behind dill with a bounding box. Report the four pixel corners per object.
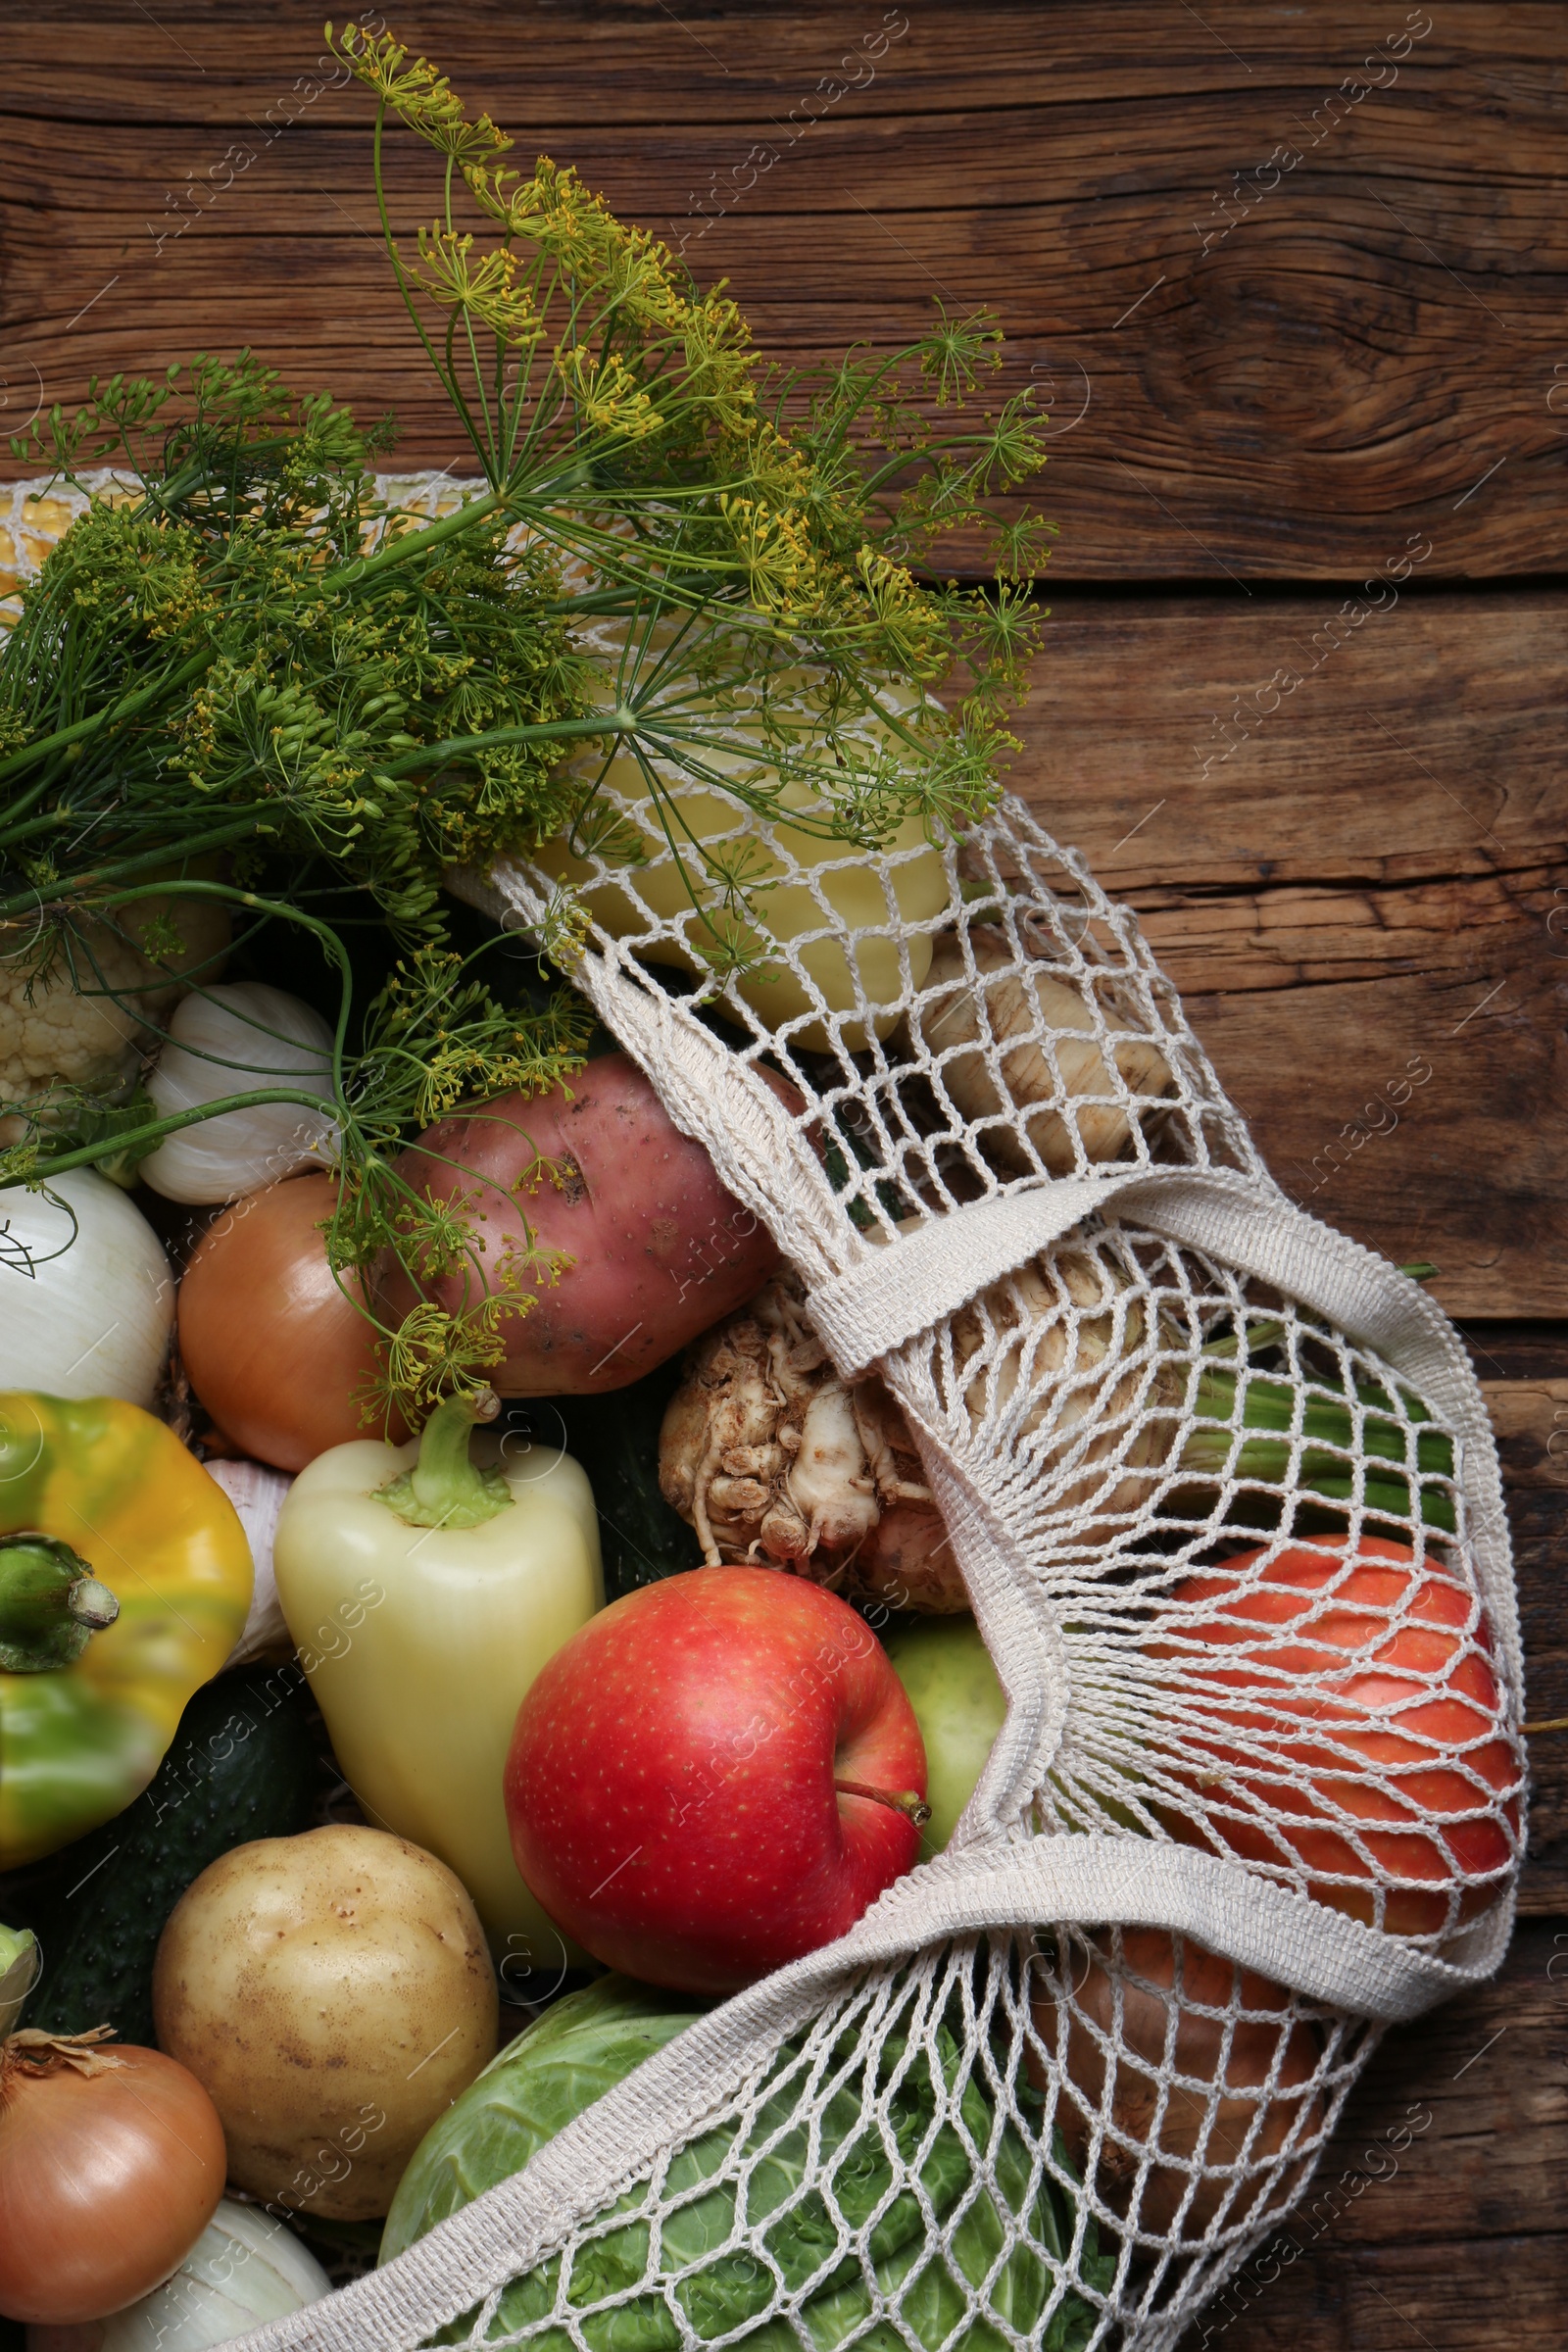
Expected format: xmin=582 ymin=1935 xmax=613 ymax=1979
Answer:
xmin=534 ymin=649 xmax=950 ymax=1052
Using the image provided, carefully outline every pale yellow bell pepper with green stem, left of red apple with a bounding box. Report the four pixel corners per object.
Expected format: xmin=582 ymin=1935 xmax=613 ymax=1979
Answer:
xmin=272 ymin=1397 xmax=604 ymax=1999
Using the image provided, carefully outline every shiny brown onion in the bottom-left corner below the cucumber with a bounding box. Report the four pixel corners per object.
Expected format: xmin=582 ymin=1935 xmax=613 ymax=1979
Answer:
xmin=0 ymin=2036 xmax=225 ymax=2327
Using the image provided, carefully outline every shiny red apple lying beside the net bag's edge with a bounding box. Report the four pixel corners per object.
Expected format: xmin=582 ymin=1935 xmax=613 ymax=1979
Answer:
xmin=506 ymin=1569 xmax=926 ymax=1992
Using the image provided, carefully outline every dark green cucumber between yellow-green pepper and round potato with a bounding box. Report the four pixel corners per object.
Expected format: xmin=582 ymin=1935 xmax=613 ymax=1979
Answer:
xmin=22 ymin=1665 xmax=324 ymax=2046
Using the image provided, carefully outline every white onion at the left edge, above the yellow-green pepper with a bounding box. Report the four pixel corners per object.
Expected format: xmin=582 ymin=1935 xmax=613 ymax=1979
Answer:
xmin=0 ymin=1169 xmax=174 ymax=1404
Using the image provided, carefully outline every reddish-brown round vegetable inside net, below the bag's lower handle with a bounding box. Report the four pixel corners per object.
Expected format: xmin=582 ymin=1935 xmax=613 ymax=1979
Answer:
xmin=1027 ymin=1929 xmax=1324 ymax=2239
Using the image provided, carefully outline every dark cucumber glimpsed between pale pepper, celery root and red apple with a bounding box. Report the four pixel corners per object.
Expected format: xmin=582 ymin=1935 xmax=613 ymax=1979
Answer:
xmin=508 ymin=1357 xmax=703 ymax=1601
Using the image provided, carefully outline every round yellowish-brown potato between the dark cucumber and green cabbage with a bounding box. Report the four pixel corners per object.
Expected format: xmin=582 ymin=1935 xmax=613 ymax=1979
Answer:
xmin=153 ymin=1828 xmax=499 ymax=2221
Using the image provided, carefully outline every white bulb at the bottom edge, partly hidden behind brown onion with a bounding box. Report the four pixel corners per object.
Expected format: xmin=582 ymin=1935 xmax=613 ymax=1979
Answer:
xmin=28 ymin=2197 xmax=331 ymax=2352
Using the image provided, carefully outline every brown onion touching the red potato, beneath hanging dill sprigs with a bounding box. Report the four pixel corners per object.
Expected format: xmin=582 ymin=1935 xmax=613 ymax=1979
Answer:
xmin=178 ymin=1176 xmax=407 ymax=1470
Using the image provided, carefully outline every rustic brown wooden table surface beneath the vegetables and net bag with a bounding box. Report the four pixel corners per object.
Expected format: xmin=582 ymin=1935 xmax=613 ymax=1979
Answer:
xmin=0 ymin=0 xmax=1568 ymax=2352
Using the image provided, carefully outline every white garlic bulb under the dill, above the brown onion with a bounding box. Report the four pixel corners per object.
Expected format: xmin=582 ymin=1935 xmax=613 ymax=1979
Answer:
xmin=136 ymin=981 xmax=336 ymax=1201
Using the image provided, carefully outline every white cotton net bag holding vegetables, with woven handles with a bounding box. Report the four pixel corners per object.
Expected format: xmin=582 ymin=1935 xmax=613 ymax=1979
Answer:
xmin=249 ymin=738 xmax=1523 ymax=2352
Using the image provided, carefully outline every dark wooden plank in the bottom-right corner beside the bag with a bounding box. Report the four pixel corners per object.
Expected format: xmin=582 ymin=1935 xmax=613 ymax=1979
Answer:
xmin=1183 ymin=1922 xmax=1568 ymax=2352
